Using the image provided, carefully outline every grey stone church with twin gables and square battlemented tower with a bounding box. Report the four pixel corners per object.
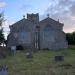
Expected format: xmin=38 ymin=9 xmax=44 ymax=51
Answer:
xmin=7 ymin=13 xmax=68 ymax=49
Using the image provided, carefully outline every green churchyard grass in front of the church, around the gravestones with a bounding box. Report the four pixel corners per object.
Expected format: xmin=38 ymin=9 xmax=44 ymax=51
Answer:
xmin=0 ymin=49 xmax=75 ymax=75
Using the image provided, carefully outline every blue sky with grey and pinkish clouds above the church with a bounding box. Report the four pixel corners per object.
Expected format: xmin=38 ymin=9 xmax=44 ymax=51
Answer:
xmin=0 ymin=0 xmax=75 ymax=37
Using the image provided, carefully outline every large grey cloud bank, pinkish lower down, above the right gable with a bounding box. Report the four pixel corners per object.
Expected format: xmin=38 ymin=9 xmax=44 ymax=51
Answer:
xmin=45 ymin=0 xmax=75 ymax=31
